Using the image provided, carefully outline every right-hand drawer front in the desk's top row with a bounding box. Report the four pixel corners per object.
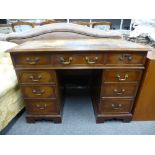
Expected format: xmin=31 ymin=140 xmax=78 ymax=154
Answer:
xmin=106 ymin=53 xmax=145 ymax=65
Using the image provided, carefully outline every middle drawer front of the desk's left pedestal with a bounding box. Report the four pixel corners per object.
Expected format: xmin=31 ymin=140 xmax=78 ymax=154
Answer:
xmin=21 ymin=86 xmax=56 ymax=98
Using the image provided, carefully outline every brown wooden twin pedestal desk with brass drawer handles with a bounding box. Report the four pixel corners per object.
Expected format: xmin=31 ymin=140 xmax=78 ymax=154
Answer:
xmin=9 ymin=39 xmax=148 ymax=123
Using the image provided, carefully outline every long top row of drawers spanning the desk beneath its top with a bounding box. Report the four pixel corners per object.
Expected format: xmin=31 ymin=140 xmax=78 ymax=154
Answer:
xmin=12 ymin=51 xmax=145 ymax=69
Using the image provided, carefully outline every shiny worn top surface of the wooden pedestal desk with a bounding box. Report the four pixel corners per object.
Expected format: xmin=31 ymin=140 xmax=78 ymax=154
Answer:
xmin=8 ymin=38 xmax=149 ymax=52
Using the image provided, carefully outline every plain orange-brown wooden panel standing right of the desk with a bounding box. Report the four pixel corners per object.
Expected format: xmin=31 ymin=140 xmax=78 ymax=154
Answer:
xmin=133 ymin=59 xmax=155 ymax=121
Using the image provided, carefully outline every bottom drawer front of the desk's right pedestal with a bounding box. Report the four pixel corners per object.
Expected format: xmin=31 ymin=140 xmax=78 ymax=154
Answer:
xmin=99 ymin=99 xmax=133 ymax=114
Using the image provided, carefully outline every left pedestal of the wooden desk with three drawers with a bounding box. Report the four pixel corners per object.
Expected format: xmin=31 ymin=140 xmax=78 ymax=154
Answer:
xmin=16 ymin=67 xmax=63 ymax=123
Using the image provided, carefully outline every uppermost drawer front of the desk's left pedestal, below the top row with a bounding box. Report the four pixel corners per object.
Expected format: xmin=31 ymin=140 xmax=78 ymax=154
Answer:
xmin=17 ymin=70 xmax=56 ymax=84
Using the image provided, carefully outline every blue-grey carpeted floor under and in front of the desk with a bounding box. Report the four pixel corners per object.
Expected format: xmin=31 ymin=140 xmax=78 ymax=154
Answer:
xmin=3 ymin=92 xmax=155 ymax=135
